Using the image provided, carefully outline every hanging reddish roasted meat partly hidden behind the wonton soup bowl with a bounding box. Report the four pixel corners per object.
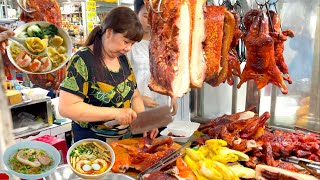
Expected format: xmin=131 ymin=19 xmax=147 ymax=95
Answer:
xmin=18 ymin=0 xmax=66 ymax=90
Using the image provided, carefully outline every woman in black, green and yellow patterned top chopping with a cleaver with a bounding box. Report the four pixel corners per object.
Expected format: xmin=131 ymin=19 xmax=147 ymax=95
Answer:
xmin=59 ymin=7 xmax=158 ymax=142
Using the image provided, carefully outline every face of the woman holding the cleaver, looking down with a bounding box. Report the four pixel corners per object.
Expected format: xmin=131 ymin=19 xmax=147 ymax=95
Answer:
xmin=102 ymin=29 xmax=135 ymax=58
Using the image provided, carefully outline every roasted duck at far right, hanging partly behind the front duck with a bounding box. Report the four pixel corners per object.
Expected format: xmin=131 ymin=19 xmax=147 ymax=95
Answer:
xmin=269 ymin=10 xmax=294 ymax=84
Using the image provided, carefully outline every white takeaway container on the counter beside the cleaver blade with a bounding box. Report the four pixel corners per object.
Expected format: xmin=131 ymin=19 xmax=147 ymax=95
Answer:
xmin=167 ymin=121 xmax=200 ymax=137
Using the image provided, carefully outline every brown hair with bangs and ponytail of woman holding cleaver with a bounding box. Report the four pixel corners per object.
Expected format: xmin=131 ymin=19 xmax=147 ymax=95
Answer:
xmin=84 ymin=6 xmax=143 ymax=80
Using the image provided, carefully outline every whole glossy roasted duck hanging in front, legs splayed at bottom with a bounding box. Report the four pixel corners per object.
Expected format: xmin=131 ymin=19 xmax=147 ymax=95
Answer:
xmin=237 ymin=10 xmax=288 ymax=94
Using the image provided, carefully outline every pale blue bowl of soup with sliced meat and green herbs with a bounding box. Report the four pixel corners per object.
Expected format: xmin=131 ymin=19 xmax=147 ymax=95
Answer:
xmin=3 ymin=141 xmax=61 ymax=179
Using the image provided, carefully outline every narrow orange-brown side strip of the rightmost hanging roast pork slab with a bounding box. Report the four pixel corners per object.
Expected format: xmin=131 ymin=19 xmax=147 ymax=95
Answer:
xmin=207 ymin=11 xmax=235 ymax=87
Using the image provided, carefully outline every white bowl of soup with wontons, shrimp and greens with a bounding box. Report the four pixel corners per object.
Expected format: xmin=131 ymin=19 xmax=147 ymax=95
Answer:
xmin=7 ymin=21 xmax=73 ymax=74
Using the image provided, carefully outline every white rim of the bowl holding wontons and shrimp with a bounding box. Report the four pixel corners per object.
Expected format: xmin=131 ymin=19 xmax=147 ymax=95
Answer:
xmin=7 ymin=21 xmax=73 ymax=74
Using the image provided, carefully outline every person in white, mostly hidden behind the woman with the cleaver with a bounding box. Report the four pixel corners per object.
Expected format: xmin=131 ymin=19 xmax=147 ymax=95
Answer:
xmin=127 ymin=0 xmax=169 ymax=108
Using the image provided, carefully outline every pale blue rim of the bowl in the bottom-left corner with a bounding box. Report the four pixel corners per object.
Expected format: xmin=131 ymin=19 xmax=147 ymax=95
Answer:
xmin=3 ymin=141 xmax=61 ymax=179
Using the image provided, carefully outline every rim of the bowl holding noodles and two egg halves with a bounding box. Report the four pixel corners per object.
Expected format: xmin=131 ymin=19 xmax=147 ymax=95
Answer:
xmin=67 ymin=138 xmax=116 ymax=179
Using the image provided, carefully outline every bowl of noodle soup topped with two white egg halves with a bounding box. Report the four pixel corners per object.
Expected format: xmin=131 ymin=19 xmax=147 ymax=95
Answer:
xmin=67 ymin=139 xmax=115 ymax=179
